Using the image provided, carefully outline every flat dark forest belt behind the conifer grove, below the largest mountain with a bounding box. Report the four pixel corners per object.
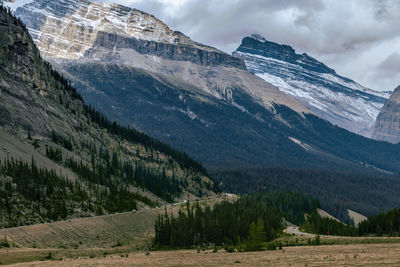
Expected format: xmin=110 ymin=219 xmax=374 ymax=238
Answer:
xmin=212 ymin=168 xmax=400 ymax=221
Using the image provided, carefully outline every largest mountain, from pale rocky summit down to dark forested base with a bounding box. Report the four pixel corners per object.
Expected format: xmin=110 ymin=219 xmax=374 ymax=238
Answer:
xmin=16 ymin=0 xmax=400 ymax=219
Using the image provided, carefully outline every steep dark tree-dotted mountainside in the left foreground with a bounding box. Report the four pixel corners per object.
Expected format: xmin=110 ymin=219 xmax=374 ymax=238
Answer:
xmin=0 ymin=7 xmax=214 ymax=227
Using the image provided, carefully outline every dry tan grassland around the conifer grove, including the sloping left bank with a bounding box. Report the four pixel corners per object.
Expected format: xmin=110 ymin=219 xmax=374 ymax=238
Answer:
xmin=0 ymin=196 xmax=400 ymax=267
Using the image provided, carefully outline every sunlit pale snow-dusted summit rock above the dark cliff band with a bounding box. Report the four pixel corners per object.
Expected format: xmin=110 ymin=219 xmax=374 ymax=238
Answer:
xmin=16 ymin=0 xmax=222 ymax=59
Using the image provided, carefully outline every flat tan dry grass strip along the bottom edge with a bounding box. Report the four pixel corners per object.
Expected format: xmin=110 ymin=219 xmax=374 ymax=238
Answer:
xmin=0 ymin=244 xmax=400 ymax=267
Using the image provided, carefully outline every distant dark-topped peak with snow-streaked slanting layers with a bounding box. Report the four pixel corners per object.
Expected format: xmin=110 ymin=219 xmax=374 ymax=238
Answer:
xmin=233 ymin=34 xmax=390 ymax=137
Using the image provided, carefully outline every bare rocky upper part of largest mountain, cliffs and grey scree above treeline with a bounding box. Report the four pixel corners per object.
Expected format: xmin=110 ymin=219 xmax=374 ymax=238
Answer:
xmin=16 ymin=0 xmax=309 ymax=112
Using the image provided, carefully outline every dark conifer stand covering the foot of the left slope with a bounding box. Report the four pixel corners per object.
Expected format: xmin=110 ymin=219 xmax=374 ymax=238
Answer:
xmin=0 ymin=158 xmax=158 ymax=227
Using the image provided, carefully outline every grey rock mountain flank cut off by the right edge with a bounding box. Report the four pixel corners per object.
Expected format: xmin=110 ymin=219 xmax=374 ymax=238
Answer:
xmin=373 ymin=86 xmax=400 ymax=143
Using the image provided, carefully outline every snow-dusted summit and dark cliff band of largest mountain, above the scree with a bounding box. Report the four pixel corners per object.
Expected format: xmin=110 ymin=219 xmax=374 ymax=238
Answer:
xmin=16 ymin=0 xmax=245 ymax=69
